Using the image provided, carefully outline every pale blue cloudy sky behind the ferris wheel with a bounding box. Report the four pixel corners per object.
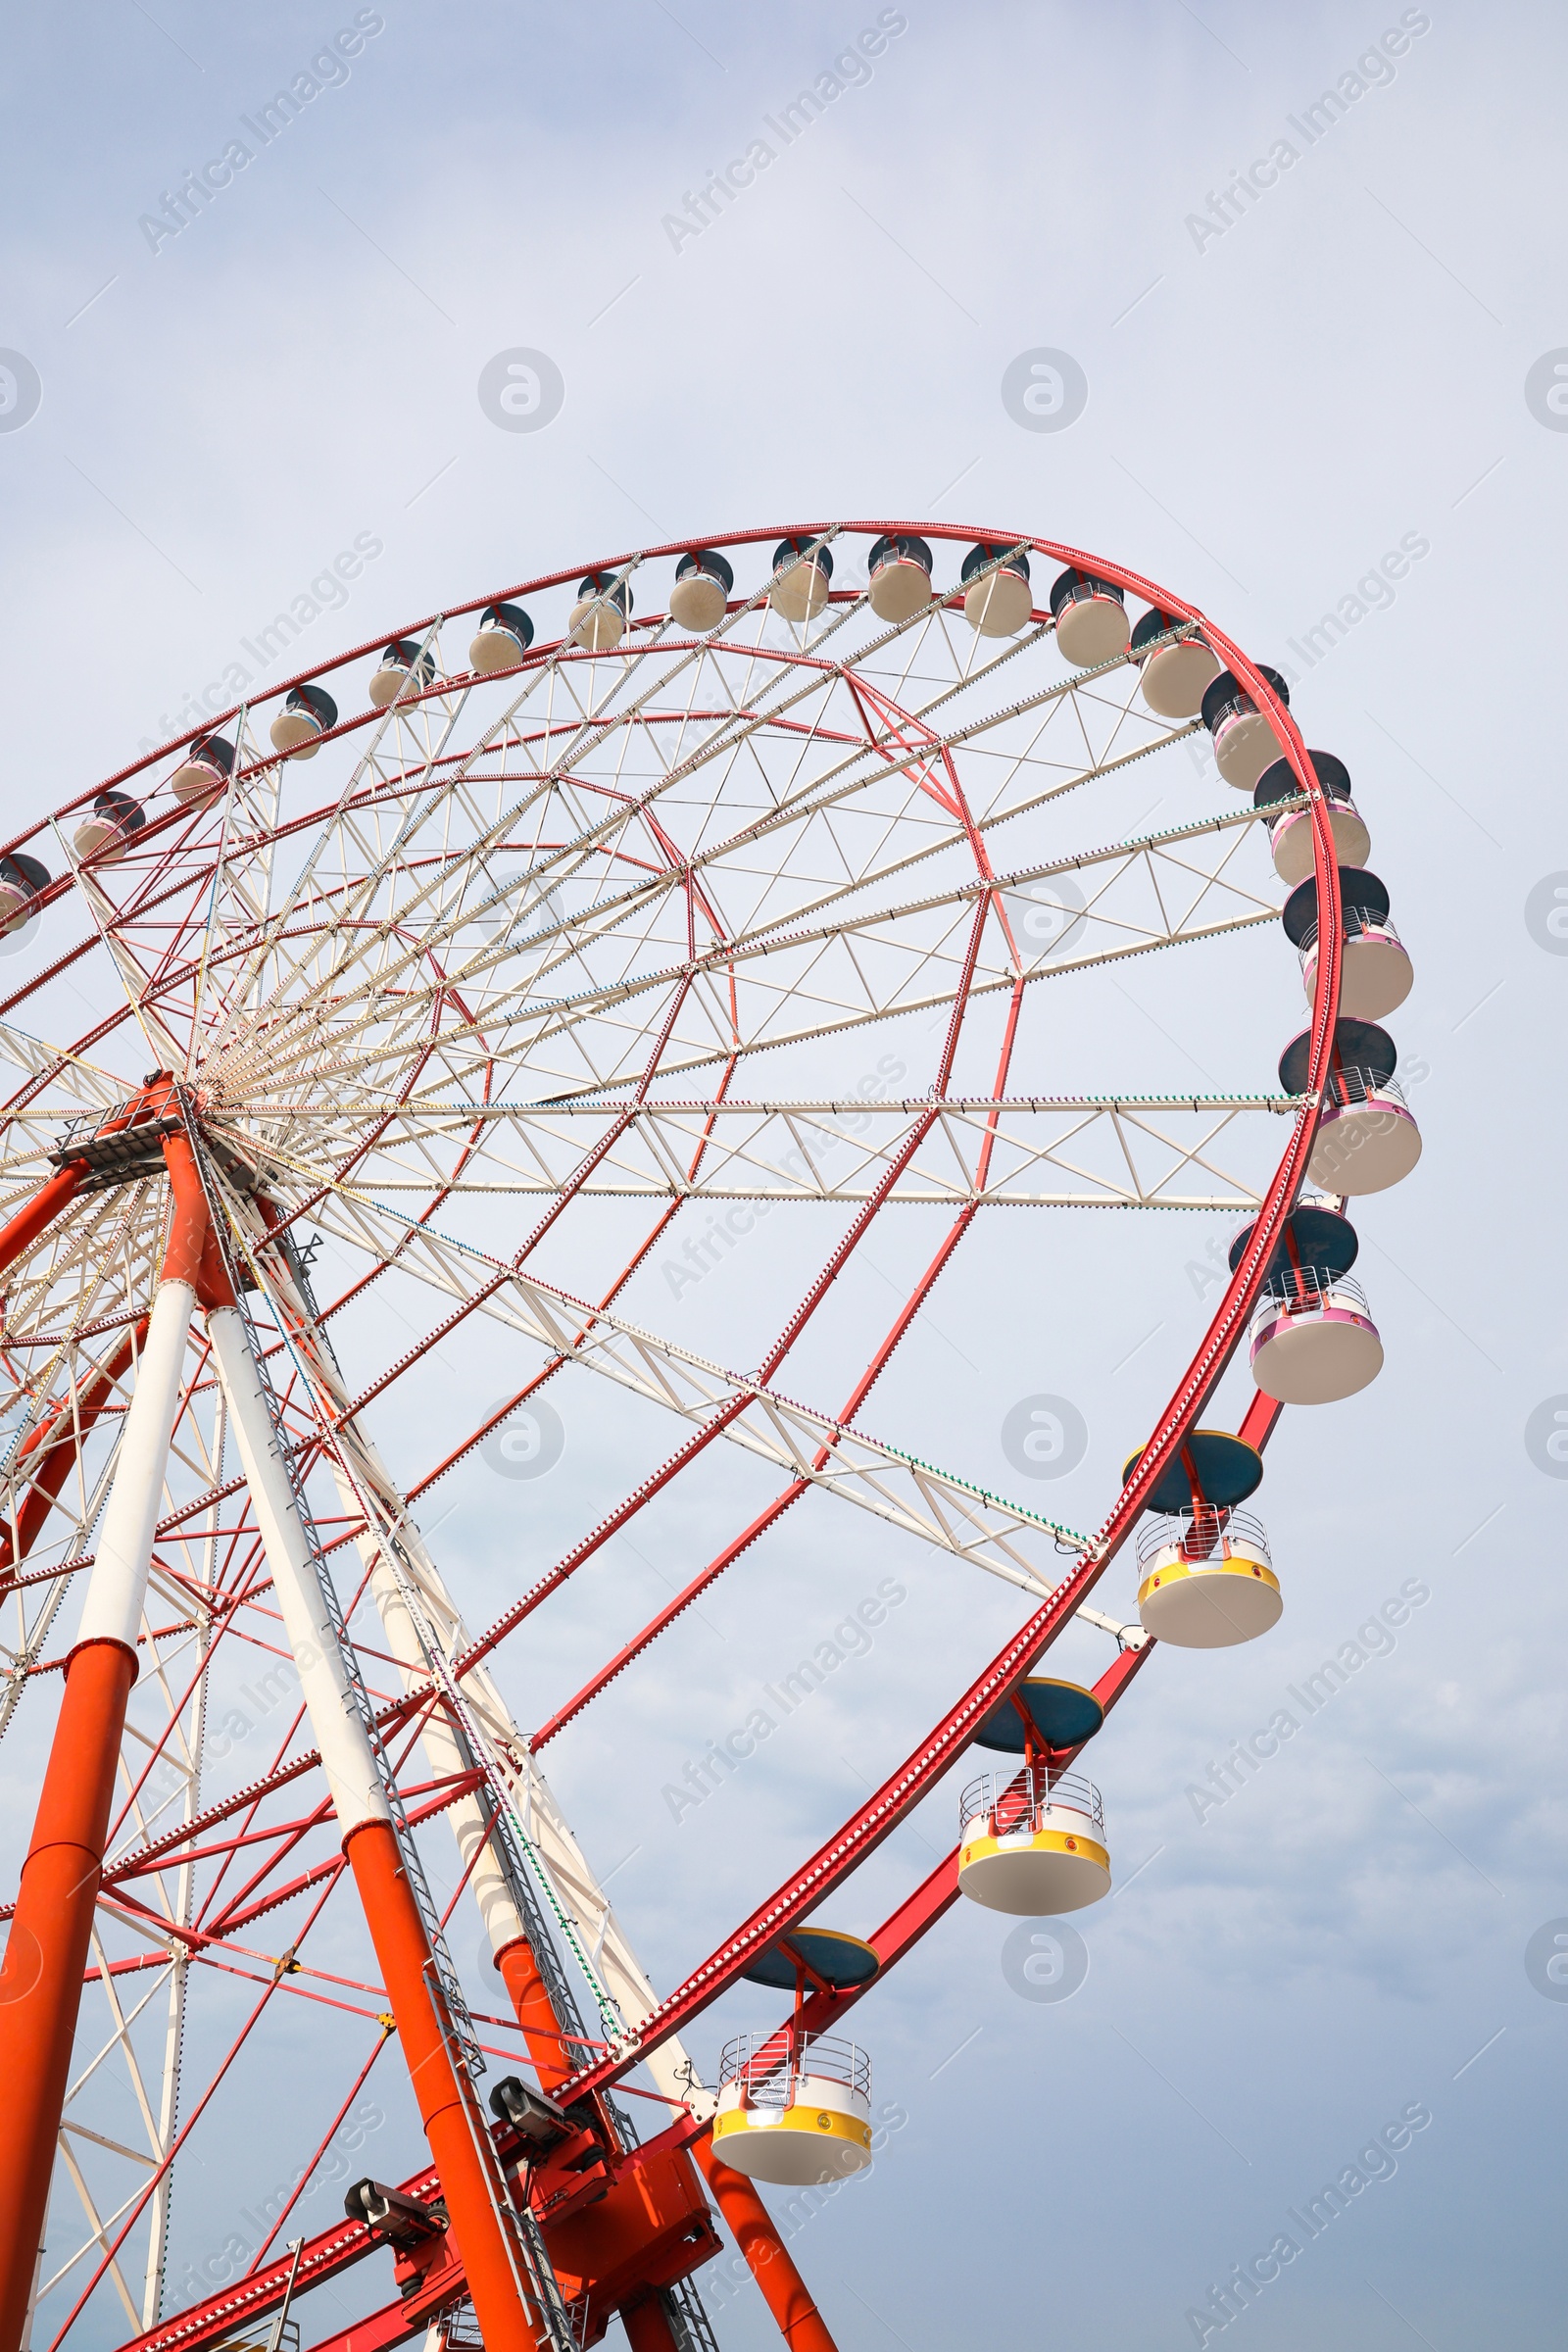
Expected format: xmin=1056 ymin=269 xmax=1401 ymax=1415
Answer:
xmin=0 ymin=14 xmax=1568 ymax=2352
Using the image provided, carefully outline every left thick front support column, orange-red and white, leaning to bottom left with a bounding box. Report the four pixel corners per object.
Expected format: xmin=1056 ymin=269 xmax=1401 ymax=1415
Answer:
xmin=0 ymin=1136 xmax=207 ymax=2352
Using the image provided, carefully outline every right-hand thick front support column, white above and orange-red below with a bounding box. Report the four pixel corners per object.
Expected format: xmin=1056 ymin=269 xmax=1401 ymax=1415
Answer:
xmin=207 ymin=1305 xmax=550 ymax=2352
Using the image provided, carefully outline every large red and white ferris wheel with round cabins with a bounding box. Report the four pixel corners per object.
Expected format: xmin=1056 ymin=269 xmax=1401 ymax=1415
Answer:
xmin=0 ymin=522 xmax=1420 ymax=2352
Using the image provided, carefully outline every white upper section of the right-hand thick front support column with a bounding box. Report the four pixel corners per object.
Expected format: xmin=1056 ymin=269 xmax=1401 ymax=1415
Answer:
xmin=207 ymin=1307 xmax=393 ymax=1835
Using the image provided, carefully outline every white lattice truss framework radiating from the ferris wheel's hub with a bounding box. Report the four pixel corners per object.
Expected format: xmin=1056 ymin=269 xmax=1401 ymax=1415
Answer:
xmin=0 ymin=534 xmax=1298 ymax=2340
